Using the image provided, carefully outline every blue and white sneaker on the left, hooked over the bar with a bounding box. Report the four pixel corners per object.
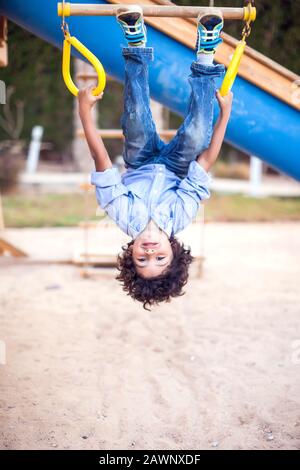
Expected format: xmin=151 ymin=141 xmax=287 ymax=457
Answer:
xmin=116 ymin=5 xmax=147 ymax=46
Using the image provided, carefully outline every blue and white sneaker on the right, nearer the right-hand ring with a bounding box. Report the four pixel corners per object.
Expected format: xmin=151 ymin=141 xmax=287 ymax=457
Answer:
xmin=195 ymin=9 xmax=224 ymax=54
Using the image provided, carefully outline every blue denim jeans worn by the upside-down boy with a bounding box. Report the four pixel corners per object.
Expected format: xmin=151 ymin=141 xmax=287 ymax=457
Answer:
xmin=121 ymin=47 xmax=225 ymax=178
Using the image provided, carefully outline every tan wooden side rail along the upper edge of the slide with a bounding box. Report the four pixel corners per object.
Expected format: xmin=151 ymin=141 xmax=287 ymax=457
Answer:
xmin=109 ymin=0 xmax=300 ymax=110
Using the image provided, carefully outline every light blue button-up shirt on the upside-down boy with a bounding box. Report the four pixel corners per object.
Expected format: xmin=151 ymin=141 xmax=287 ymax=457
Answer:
xmin=91 ymin=161 xmax=212 ymax=239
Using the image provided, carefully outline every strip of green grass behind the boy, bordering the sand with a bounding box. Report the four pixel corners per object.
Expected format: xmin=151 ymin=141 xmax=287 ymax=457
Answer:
xmin=3 ymin=193 xmax=300 ymax=228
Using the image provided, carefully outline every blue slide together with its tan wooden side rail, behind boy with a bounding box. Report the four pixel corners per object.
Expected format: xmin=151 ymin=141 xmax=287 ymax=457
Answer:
xmin=0 ymin=0 xmax=300 ymax=176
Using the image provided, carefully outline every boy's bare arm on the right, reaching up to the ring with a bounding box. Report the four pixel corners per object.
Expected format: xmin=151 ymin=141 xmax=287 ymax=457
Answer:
xmin=197 ymin=91 xmax=233 ymax=171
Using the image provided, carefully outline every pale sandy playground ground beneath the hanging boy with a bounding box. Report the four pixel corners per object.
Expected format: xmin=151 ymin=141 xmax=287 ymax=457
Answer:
xmin=0 ymin=224 xmax=300 ymax=450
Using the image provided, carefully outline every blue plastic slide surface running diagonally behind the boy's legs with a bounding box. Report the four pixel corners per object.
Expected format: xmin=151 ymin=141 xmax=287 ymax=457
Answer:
xmin=0 ymin=0 xmax=300 ymax=181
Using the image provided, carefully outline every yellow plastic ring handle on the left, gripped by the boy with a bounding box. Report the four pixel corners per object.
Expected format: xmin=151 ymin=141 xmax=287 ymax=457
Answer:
xmin=62 ymin=35 xmax=106 ymax=96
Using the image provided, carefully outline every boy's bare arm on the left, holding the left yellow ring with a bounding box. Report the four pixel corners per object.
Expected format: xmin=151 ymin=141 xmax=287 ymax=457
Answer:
xmin=78 ymin=86 xmax=112 ymax=171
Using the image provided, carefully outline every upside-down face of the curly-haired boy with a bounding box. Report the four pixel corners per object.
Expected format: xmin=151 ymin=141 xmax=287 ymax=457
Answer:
xmin=132 ymin=231 xmax=173 ymax=278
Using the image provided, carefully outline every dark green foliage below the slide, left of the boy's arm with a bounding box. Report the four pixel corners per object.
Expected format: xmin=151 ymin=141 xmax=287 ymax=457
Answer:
xmin=0 ymin=22 xmax=73 ymax=150
